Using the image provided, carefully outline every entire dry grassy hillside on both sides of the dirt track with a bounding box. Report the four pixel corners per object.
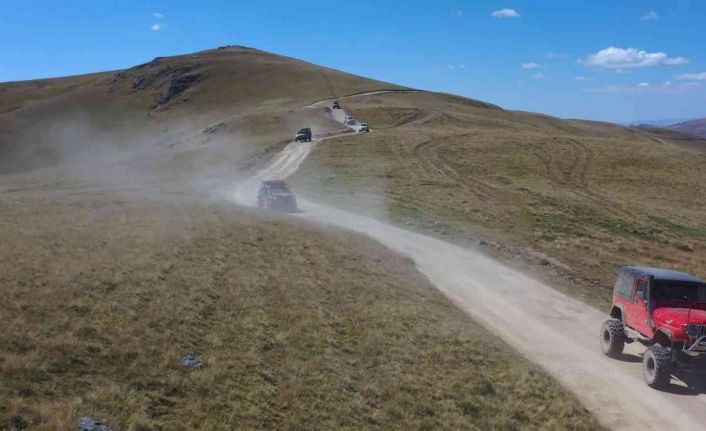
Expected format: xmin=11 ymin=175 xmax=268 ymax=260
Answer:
xmin=11 ymin=47 xmax=706 ymax=430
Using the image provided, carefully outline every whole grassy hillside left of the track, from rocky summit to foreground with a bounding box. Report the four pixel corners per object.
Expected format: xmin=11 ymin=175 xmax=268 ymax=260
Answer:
xmin=0 ymin=48 xmax=601 ymax=430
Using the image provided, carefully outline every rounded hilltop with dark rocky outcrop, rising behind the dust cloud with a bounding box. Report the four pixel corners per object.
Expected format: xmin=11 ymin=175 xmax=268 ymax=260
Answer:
xmin=0 ymin=47 xmax=400 ymax=174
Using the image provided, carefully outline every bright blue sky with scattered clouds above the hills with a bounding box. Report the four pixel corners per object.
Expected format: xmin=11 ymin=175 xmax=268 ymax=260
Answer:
xmin=0 ymin=0 xmax=706 ymax=122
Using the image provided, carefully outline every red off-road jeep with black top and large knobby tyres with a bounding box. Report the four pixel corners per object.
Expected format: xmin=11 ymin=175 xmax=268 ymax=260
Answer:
xmin=601 ymin=266 xmax=706 ymax=388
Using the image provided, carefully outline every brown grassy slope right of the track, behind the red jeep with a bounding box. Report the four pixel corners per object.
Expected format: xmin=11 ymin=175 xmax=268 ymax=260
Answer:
xmin=295 ymin=93 xmax=706 ymax=305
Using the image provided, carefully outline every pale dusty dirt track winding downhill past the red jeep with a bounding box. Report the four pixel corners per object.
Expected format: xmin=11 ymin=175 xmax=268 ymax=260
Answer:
xmin=232 ymin=98 xmax=706 ymax=430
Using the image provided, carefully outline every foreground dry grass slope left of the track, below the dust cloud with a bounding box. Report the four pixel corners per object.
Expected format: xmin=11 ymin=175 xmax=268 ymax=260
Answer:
xmin=0 ymin=191 xmax=600 ymax=430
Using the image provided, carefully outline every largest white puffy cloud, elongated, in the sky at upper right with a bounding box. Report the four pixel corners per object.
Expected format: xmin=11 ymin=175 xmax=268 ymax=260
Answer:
xmin=579 ymin=46 xmax=689 ymax=69
